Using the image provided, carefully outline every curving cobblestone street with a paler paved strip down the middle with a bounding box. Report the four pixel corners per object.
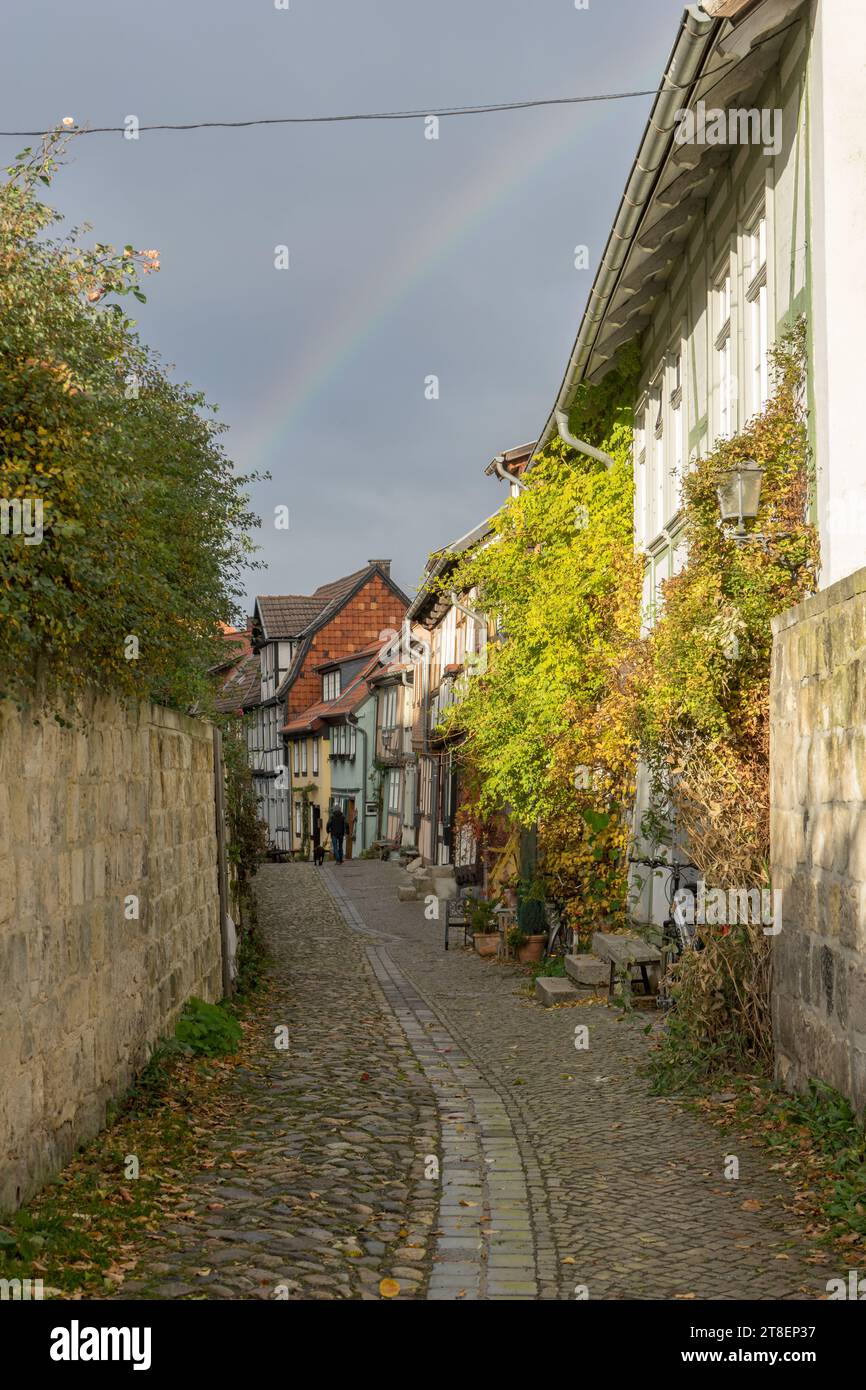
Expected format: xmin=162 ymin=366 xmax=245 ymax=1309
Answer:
xmin=122 ymin=860 xmax=827 ymax=1300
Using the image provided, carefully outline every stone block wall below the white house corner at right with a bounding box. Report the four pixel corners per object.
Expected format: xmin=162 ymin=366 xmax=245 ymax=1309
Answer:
xmin=770 ymin=570 xmax=866 ymax=1111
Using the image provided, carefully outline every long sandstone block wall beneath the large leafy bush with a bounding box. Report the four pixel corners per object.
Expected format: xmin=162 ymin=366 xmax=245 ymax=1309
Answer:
xmin=0 ymin=694 xmax=221 ymax=1209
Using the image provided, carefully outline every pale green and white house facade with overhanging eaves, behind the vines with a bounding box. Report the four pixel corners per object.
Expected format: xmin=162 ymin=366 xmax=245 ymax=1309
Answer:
xmin=537 ymin=0 xmax=866 ymax=920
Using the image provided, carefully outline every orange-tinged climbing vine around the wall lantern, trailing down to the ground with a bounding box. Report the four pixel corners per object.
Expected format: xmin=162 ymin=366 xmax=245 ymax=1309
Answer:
xmin=634 ymin=320 xmax=819 ymax=1076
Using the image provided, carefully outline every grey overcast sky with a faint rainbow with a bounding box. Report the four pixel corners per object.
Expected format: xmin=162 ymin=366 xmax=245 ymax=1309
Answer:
xmin=0 ymin=0 xmax=683 ymax=614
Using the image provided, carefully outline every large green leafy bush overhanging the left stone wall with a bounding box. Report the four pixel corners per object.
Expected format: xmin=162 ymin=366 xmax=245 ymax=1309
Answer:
xmin=0 ymin=132 xmax=259 ymax=709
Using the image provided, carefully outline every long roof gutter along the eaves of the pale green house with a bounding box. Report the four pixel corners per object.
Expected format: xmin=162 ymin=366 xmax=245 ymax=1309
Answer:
xmin=525 ymin=0 xmax=717 ymax=473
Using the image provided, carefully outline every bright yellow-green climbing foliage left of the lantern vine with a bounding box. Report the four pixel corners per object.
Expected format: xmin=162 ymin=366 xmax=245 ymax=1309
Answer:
xmin=445 ymin=344 xmax=641 ymax=931
